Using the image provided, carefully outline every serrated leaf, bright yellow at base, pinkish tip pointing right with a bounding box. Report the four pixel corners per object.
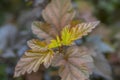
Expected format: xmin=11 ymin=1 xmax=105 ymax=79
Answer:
xmin=61 ymin=21 xmax=99 ymax=45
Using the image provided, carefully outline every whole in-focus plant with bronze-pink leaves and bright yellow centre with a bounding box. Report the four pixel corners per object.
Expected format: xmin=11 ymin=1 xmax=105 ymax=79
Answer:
xmin=14 ymin=0 xmax=99 ymax=80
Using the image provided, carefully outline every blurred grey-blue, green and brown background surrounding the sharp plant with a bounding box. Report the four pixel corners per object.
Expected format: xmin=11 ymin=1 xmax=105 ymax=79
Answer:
xmin=0 ymin=0 xmax=120 ymax=80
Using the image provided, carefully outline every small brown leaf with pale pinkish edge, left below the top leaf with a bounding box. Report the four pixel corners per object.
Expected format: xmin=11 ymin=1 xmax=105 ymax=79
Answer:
xmin=32 ymin=21 xmax=56 ymax=40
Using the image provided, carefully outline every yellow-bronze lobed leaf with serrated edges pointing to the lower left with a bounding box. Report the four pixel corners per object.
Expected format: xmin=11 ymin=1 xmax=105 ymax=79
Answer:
xmin=14 ymin=40 xmax=54 ymax=77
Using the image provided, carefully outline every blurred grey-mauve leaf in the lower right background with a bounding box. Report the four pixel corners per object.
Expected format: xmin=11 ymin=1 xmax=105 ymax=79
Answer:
xmin=93 ymin=53 xmax=112 ymax=80
